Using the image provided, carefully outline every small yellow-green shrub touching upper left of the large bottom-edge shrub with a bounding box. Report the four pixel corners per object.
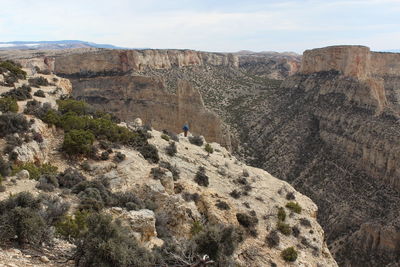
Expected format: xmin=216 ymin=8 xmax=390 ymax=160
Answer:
xmin=55 ymin=210 xmax=90 ymax=240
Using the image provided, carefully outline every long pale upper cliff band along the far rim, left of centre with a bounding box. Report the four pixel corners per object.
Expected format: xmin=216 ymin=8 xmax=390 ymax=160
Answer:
xmin=53 ymin=50 xmax=238 ymax=75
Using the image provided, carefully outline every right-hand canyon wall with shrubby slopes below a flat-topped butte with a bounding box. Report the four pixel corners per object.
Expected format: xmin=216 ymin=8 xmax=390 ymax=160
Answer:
xmin=243 ymin=46 xmax=400 ymax=266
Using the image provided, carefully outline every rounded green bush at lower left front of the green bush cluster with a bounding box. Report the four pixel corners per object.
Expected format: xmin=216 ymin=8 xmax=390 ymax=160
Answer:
xmin=62 ymin=130 xmax=95 ymax=155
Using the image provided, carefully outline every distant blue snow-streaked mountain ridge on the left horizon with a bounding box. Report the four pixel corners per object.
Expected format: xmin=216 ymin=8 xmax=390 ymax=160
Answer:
xmin=0 ymin=40 xmax=127 ymax=50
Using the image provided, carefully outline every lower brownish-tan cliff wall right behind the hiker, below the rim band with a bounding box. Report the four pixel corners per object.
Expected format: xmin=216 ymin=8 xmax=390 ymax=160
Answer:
xmin=72 ymin=75 xmax=231 ymax=148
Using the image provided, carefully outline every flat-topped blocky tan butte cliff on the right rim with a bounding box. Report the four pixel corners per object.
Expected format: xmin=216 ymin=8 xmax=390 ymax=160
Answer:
xmin=300 ymin=46 xmax=400 ymax=111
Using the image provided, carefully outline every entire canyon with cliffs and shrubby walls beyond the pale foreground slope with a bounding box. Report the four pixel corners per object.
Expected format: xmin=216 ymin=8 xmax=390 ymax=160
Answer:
xmin=0 ymin=46 xmax=400 ymax=266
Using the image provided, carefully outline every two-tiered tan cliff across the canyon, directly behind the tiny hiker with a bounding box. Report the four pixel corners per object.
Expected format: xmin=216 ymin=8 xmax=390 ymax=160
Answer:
xmin=51 ymin=50 xmax=238 ymax=149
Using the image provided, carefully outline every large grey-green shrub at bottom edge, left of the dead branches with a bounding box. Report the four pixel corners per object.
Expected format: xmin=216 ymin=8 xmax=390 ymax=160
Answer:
xmin=75 ymin=214 xmax=155 ymax=267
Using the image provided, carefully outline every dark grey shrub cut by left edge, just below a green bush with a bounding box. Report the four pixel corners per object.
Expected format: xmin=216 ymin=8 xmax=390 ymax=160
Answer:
xmin=0 ymin=113 xmax=29 ymax=137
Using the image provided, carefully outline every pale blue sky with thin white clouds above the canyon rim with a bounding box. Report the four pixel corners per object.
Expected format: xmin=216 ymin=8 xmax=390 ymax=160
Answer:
xmin=0 ymin=0 xmax=400 ymax=53
